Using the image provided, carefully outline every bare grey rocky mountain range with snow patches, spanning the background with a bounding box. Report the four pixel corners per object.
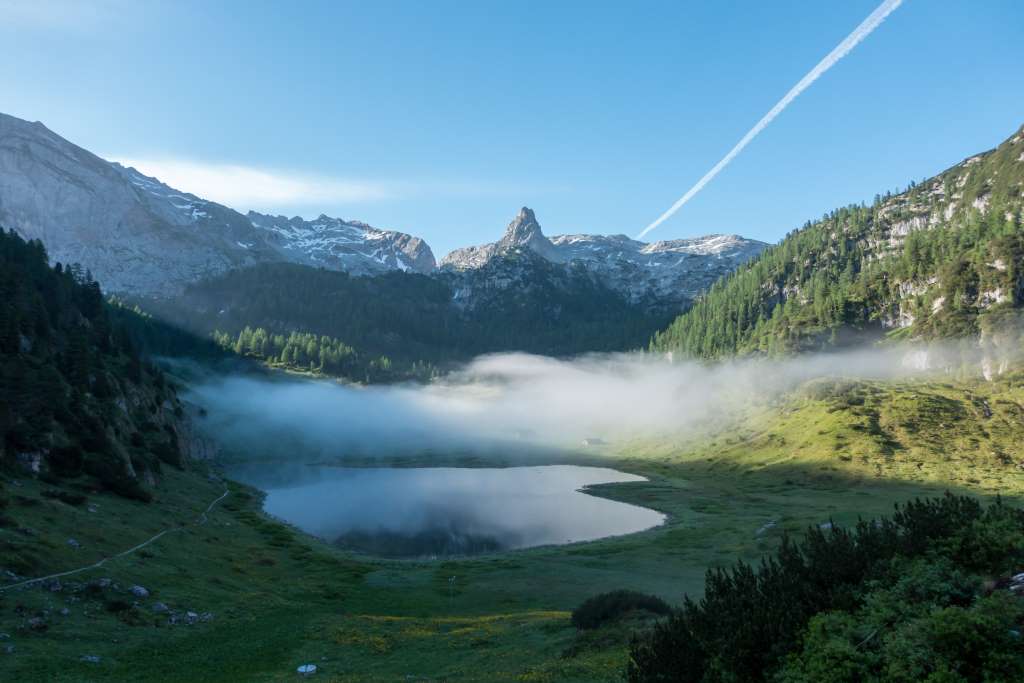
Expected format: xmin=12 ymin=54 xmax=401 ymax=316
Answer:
xmin=0 ymin=115 xmax=767 ymax=310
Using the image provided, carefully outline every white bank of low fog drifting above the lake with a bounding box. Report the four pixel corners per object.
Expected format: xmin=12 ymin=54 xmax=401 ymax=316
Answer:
xmin=189 ymin=349 xmax=962 ymax=458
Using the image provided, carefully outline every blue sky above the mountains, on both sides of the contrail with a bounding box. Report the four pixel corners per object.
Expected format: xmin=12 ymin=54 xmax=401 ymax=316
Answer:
xmin=0 ymin=0 xmax=1024 ymax=256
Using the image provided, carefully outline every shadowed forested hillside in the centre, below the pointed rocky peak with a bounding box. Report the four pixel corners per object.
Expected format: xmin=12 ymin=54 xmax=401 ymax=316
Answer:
xmin=144 ymin=251 xmax=668 ymax=380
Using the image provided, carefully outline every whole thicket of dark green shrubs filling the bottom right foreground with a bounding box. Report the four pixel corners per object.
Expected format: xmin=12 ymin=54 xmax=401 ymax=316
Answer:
xmin=629 ymin=495 xmax=1024 ymax=682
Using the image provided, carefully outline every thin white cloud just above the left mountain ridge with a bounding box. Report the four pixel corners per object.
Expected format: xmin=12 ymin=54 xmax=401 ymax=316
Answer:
xmin=113 ymin=158 xmax=402 ymax=210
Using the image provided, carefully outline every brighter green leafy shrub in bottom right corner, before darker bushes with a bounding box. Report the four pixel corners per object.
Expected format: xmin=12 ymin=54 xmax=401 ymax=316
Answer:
xmin=775 ymin=559 xmax=1024 ymax=683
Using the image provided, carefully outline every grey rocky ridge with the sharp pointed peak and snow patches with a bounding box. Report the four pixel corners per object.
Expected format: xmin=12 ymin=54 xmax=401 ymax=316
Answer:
xmin=440 ymin=207 xmax=768 ymax=307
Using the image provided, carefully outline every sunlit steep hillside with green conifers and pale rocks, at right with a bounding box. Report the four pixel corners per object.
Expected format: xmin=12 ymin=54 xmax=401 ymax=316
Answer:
xmin=650 ymin=128 xmax=1024 ymax=357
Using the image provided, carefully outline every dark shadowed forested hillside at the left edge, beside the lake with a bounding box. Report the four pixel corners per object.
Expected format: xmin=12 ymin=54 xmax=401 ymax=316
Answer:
xmin=0 ymin=230 xmax=197 ymax=500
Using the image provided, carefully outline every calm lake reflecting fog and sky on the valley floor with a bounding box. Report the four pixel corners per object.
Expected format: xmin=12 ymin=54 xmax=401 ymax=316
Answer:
xmin=230 ymin=465 xmax=665 ymax=557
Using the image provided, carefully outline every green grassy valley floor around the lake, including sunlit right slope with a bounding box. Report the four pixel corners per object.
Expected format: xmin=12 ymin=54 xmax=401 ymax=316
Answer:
xmin=0 ymin=375 xmax=1024 ymax=681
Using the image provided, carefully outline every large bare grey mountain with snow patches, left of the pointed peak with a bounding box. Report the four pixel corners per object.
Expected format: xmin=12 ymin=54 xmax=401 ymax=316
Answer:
xmin=0 ymin=115 xmax=434 ymax=296
